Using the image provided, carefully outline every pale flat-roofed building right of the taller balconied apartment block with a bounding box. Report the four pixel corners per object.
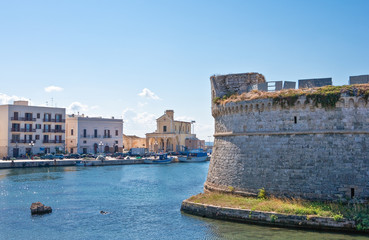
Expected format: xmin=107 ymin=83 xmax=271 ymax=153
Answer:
xmin=66 ymin=114 xmax=123 ymax=154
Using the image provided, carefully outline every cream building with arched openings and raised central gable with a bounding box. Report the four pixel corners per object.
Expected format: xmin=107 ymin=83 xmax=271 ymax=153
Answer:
xmin=146 ymin=110 xmax=196 ymax=152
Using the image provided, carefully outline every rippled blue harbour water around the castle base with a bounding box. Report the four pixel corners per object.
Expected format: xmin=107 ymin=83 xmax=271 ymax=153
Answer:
xmin=0 ymin=162 xmax=367 ymax=239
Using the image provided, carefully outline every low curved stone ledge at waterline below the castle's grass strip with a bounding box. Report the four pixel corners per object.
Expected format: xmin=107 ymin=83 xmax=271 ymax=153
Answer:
xmin=181 ymin=199 xmax=369 ymax=233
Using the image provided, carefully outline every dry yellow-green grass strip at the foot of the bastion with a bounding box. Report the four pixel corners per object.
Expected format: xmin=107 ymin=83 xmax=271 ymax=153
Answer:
xmin=188 ymin=192 xmax=369 ymax=224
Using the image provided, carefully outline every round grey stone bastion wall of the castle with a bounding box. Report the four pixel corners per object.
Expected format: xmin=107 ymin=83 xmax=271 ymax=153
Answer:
xmin=204 ymin=73 xmax=369 ymax=200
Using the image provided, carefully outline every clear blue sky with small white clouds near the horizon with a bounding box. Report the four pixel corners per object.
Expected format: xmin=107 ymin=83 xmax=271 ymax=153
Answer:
xmin=0 ymin=0 xmax=369 ymax=140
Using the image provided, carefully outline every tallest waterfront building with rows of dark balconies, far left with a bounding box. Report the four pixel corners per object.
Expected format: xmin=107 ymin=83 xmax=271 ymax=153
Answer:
xmin=0 ymin=101 xmax=65 ymax=158
